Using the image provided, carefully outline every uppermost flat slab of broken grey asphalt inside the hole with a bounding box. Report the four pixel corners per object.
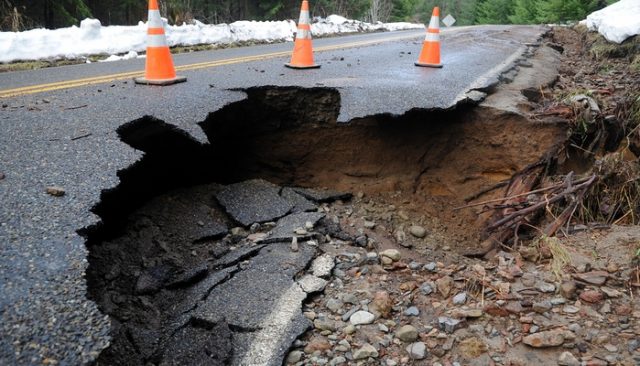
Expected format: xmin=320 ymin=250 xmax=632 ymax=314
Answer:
xmin=216 ymin=179 xmax=294 ymax=226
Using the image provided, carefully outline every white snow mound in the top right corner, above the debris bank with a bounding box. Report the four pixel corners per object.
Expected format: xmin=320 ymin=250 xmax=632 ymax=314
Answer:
xmin=584 ymin=0 xmax=640 ymax=43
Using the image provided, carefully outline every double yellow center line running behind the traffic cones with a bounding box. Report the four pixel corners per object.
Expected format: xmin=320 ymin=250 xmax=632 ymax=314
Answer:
xmin=0 ymin=31 xmax=419 ymax=98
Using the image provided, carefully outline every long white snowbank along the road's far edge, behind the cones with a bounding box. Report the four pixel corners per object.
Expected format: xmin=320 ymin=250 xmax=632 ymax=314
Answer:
xmin=0 ymin=15 xmax=424 ymax=62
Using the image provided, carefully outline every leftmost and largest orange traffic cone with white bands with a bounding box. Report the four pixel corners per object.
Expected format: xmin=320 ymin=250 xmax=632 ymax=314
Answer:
xmin=134 ymin=0 xmax=187 ymax=85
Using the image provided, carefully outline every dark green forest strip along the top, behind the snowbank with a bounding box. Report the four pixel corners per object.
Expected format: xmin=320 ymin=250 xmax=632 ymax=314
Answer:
xmin=0 ymin=0 xmax=616 ymax=32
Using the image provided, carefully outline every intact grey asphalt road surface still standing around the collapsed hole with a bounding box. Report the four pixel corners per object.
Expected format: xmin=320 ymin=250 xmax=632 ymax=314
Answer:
xmin=0 ymin=26 xmax=545 ymax=364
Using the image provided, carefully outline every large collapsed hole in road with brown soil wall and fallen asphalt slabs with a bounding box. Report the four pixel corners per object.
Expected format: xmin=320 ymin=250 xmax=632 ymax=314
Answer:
xmin=82 ymin=87 xmax=566 ymax=365
